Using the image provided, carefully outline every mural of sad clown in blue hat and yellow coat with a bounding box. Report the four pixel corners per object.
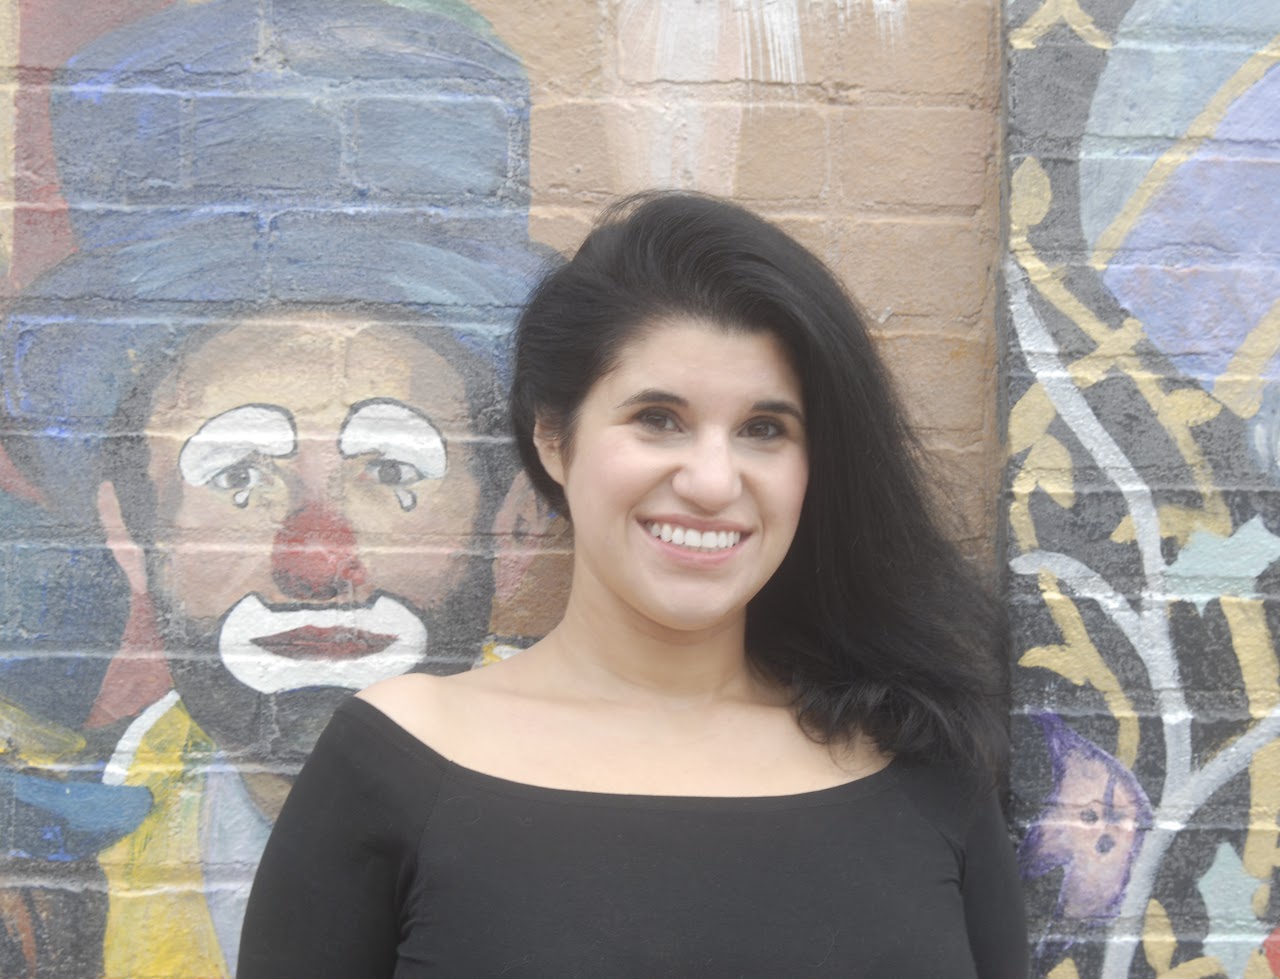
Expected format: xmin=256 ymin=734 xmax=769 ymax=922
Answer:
xmin=0 ymin=0 xmax=566 ymax=976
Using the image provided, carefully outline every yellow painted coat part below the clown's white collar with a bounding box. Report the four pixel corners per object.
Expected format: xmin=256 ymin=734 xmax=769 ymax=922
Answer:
xmin=99 ymin=704 xmax=228 ymax=979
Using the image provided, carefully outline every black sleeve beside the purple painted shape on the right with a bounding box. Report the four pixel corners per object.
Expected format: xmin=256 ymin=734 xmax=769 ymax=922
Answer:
xmin=961 ymin=793 xmax=1030 ymax=979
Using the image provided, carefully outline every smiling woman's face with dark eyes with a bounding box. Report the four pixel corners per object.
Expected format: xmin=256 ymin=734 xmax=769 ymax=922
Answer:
xmin=538 ymin=317 xmax=809 ymax=632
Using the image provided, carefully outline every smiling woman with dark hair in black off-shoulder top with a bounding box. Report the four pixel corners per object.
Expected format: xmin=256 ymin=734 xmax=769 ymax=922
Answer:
xmin=241 ymin=193 xmax=1027 ymax=979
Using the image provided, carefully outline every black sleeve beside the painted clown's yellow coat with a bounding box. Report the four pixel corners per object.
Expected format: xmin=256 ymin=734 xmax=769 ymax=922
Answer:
xmin=237 ymin=700 xmax=439 ymax=979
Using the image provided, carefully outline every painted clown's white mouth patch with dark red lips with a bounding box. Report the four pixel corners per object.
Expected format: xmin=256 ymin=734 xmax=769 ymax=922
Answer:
xmin=218 ymin=595 xmax=426 ymax=694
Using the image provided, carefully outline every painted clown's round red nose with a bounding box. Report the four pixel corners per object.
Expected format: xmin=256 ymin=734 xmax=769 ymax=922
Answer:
xmin=271 ymin=503 xmax=365 ymax=601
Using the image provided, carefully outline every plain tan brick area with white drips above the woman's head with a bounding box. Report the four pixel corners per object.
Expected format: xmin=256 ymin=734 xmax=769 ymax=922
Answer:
xmin=474 ymin=0 xmax=1001 ymax=562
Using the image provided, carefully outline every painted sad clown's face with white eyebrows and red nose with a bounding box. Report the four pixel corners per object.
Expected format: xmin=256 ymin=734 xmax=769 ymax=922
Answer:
xmin=104 ymin=314 xmax=492 ymax=763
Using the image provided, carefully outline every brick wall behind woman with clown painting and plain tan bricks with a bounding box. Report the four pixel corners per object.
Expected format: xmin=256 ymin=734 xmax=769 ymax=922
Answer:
xmin=0 ymin=0 xmax=1004 ymax=976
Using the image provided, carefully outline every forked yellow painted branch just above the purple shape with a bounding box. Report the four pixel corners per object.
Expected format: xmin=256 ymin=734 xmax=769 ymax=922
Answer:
xmin=1018 ymin=572 xmax=1138 ymax=768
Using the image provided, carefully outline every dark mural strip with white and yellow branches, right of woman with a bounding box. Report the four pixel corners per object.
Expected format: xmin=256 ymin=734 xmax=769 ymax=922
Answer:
xmin=1006 ymin=0 xmax=1280 ymax=979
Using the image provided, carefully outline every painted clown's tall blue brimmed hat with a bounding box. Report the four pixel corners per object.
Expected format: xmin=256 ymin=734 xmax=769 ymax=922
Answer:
xmin=3 ymin=0 xmax=552 ymax=509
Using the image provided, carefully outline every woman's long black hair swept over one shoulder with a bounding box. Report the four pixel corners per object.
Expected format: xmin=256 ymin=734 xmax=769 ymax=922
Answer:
xmin=511 ymin=192 xmax=1007 ymax=773
